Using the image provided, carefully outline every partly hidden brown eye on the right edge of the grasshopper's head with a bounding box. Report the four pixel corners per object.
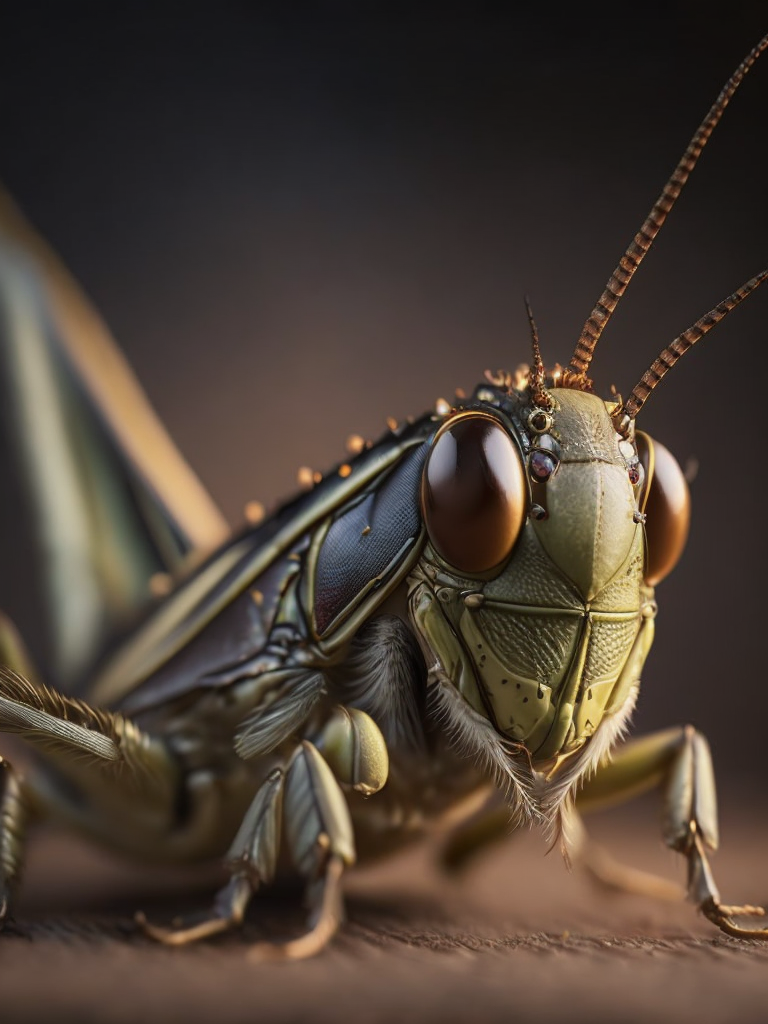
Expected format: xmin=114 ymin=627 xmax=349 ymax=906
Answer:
xmin=636 ymin=431 xmax=690 ymax=587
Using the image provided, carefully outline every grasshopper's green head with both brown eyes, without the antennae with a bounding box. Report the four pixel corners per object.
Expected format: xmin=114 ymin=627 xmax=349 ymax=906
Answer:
xmin=411 ymin=386 xmax=688 ymax=764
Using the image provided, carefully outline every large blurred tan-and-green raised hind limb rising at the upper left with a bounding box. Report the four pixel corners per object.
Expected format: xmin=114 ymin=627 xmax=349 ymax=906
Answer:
xmin=0 ymin=189 xmax=229 ymax=689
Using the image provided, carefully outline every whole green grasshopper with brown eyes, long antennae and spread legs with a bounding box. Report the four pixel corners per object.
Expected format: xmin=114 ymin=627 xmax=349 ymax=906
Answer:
xmin=0 ymin=36 xmax=768 ymax=958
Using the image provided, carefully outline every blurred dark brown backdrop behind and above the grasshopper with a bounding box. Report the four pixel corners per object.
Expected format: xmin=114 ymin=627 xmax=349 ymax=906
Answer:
xmin=0 ymin=6 xmax=768 ymax=795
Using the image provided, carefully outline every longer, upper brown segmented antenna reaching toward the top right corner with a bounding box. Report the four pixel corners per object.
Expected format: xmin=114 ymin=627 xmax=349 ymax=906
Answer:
xmin=567 ymin=35 xmax=768 ymax=386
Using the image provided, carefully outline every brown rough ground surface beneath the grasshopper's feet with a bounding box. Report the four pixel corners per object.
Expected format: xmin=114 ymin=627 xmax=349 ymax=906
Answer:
xmin=0 ymin=803 xmax=768 ymax=1024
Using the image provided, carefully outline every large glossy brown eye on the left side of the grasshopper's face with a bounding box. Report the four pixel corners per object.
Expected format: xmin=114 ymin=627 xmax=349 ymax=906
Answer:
xmin=421 ymin=415 xmax=528 ymax=572
